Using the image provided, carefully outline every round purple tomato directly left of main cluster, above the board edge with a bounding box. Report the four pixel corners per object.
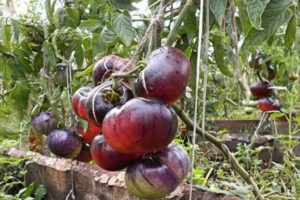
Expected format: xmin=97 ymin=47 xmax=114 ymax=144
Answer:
xmin=47 ymin=129 xmax=82 ymax=158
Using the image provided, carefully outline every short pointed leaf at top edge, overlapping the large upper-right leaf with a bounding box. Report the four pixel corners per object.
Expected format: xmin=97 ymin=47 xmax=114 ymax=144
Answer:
xmin=246 ymin=0 xmax=270 ymax=29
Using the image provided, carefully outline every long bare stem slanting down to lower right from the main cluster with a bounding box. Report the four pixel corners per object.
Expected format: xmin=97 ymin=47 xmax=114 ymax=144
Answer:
xmin=172 ymin=105 xmax=263 ymax=200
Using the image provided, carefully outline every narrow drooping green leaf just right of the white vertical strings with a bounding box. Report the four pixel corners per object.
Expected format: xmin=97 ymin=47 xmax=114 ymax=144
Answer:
xmin=212 ymin=34 xmax=233 ymax=76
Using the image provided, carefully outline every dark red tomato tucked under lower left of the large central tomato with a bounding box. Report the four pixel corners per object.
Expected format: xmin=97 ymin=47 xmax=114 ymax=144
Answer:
xmin=91 ymin=135 xmax=143 ymax=171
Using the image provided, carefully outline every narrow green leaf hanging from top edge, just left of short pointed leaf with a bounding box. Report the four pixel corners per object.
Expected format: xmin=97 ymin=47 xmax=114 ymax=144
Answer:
xmin=237 ymin=0 xmax=252 ymax=36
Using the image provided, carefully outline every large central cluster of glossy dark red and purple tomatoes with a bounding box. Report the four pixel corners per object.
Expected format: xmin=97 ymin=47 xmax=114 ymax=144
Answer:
xmin=31 ymin=47 xmax=191 ymax=199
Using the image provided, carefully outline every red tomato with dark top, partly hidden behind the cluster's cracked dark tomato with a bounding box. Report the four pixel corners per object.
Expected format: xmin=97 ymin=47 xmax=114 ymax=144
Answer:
xmin=71 ymin=86 xmax=92 ymax=120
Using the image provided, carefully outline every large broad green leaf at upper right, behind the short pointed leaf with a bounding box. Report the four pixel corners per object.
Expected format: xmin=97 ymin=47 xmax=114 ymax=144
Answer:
xmin=242 ymin=0 xmax=293 ymax=50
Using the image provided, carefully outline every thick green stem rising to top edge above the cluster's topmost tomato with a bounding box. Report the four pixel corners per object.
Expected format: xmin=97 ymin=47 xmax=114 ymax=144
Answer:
xmin=165 ymin=0 xmax=193 ymax=46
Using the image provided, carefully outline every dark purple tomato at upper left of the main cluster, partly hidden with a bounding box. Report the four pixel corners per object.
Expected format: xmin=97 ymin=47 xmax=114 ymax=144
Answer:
xmin=93 ymin=55 xmax=134 ymax=85
